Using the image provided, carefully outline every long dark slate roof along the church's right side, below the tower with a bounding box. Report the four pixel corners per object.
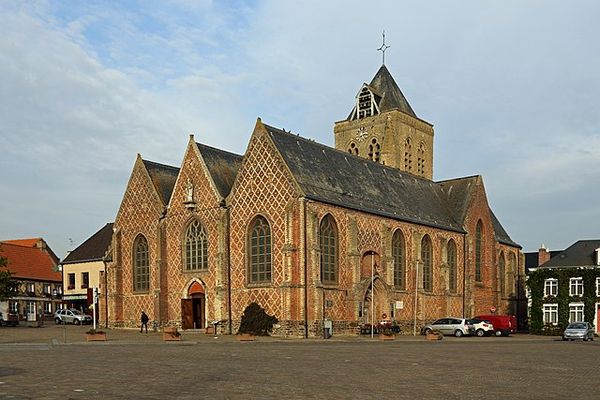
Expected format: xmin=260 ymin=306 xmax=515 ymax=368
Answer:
xmin=264 ymin=125 xmax=464 ymax=233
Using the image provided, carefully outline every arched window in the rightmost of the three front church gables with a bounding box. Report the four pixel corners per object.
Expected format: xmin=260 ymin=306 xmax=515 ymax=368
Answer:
xmin=248 ymin=215 xmax=271 ymax=283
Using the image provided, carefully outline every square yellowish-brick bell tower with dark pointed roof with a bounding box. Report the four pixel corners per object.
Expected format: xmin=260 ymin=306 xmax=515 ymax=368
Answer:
xmin=333 ymin=64 xmax=433 ymax=179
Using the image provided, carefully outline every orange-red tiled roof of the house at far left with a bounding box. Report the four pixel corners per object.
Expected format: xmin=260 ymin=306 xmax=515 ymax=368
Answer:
xmin=0 ymin=241 xmax=62 ymax=282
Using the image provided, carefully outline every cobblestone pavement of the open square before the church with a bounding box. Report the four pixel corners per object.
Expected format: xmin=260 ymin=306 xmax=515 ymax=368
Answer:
xmin=0 ymin=325 xmax=600 ymax=400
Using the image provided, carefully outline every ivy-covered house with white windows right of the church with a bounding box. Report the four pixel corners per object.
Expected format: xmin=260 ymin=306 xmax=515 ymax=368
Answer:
xmin=527 ymin=240 xmax=600 ymax=333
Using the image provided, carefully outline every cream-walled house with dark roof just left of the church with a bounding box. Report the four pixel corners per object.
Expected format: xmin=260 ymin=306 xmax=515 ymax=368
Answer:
xmin=61 ymin=223 xmax=113 ymax=318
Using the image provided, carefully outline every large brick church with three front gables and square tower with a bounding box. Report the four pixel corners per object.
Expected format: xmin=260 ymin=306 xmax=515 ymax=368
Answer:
xmin=101 ymin=66 xmax=524 ymax=337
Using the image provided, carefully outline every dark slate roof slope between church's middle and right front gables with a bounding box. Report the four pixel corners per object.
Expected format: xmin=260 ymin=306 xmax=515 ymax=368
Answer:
xmin=196 ymin=143 xmax=243 ymax=198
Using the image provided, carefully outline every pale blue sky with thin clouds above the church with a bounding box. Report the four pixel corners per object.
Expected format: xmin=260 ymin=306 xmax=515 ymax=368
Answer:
xmin=0 ymin=0 xmax=600 ymax=258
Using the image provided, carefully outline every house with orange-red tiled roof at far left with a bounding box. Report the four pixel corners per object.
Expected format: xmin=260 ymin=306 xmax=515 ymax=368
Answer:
xmin=0 ymin=238 xmax=62 ymax=321
